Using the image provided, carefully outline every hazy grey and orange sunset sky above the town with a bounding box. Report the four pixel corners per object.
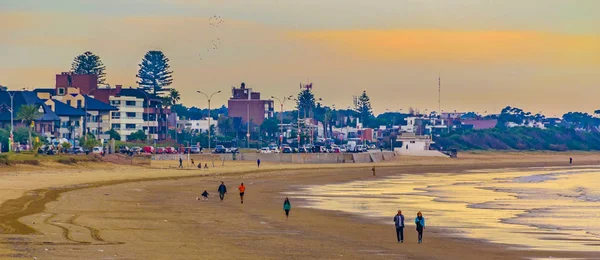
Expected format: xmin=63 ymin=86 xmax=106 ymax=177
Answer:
xmin=0 ymin=0 xmax=600 ymax=116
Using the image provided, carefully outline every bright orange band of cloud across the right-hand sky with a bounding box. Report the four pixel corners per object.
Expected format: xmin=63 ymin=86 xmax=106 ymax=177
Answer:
xmin=291 ymin=30 xmax=600 ymax=65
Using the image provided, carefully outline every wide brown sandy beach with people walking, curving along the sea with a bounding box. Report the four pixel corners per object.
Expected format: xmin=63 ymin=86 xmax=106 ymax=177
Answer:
xmin=0 ymin=153 xmax=600 ymax=259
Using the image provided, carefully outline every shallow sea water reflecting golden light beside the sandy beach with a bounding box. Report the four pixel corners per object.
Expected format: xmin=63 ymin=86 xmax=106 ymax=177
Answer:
xmin=288 ymin=167 xmax=600 ymax=252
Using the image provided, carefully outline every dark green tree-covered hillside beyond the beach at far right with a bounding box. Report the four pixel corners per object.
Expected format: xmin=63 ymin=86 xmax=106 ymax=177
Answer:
xmin=434 ymin=127 xmax=600 ymax=151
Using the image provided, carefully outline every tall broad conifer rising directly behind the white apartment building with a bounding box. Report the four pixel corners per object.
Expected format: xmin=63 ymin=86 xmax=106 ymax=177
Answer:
xmin=136 ymin=51 xmax=173 ymax=95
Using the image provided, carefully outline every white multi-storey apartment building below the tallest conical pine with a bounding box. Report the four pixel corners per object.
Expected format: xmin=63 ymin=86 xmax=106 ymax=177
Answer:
xmin=109 ymin=96 xmax=145 ymax=140
